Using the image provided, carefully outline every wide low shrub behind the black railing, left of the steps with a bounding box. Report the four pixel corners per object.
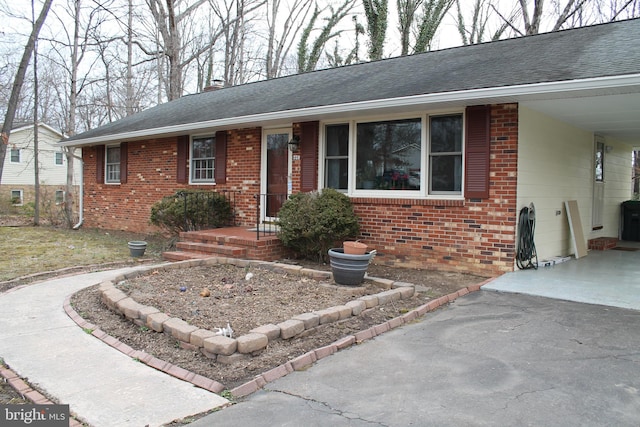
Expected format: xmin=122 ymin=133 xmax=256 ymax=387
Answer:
xmin=149 ymin=191 xmax=233 ymax=234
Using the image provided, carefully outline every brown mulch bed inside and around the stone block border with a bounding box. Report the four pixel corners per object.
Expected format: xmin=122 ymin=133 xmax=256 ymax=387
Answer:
xmin=71 ymin=265 xmax=484 ymax=389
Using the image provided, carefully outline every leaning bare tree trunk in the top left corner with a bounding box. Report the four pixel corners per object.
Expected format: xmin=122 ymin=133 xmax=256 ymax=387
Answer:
xmin=0 ymin=0 xmax=53 ymax=186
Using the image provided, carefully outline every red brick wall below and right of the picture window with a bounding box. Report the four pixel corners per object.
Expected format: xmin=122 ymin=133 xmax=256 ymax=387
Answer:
xmin=352 ymin=104 xmax=518 ymax=275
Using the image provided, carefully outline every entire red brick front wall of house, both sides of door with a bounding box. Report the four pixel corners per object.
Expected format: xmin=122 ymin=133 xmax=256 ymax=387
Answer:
xmin=83 ymin=104 xmax=518 ymax=275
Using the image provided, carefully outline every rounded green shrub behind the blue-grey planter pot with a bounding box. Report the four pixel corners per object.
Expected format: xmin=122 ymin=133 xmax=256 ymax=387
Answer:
xmin=278 ymin=188 xmax=360 ymax=261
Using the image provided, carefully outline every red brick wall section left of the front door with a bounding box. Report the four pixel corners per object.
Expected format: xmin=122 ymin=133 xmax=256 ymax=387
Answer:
xmin=83 ymin=128 xmax=261 ymax=233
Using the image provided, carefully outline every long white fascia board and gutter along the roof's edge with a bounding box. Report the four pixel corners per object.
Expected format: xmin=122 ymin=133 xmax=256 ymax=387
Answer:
xmin=60 ymin=74 xmax=640 ymax=146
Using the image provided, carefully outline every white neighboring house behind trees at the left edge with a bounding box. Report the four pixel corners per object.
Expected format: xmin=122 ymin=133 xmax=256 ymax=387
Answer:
xmin=0 ymin=123 xmax=81 ymax=210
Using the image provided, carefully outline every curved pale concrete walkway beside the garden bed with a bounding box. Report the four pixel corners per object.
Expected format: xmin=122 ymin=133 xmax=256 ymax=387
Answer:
xmin=0 ymin=266 xmax=228 ymax=427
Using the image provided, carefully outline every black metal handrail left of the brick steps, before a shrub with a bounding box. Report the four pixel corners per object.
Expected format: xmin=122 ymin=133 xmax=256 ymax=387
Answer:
xmin=176 ymin=190 xmax=237 ymax=231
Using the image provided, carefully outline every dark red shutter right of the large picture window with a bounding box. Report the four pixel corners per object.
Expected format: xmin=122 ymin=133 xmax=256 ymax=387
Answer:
xmin=464 ymin=105 xmax=491 ymax=199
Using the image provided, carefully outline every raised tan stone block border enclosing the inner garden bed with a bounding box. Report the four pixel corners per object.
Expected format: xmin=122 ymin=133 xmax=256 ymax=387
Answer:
xmin=99 ymin=258 xmax=415 ymax=364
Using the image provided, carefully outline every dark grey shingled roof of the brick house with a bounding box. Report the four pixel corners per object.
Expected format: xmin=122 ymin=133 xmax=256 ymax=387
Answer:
xmin=64 ymin=19 xmax=640 ymax=145
